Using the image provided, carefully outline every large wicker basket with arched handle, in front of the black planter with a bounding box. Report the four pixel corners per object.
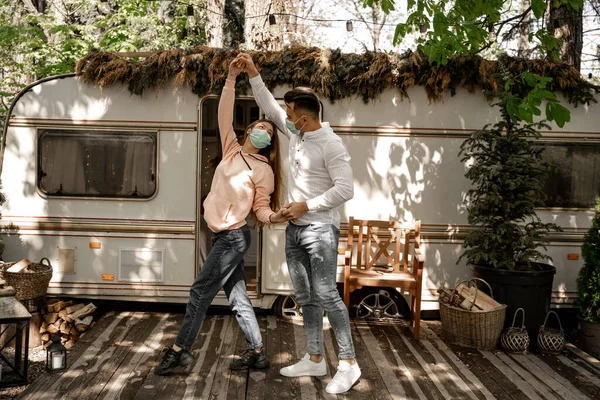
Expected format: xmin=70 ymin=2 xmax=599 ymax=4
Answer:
xmin=440 ymin=278 xmax=506 ymax=350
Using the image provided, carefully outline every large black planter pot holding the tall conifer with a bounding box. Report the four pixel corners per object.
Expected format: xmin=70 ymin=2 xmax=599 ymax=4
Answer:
xmin=472 ymin=263 xmax=556 ymax=343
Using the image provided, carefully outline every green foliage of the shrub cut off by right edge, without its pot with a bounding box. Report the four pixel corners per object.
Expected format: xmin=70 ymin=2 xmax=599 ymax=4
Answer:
xmin=575 ymin=196 xmax=600 ymax=322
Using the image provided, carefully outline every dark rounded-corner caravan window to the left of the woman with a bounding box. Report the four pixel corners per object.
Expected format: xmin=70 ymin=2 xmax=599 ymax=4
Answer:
xmin=37 ymin=129 xmax=157 ymax=199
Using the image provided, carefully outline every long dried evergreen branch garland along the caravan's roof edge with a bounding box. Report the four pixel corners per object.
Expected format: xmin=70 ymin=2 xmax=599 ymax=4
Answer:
xmin=75 ymin=46 xmax=600 ymax=106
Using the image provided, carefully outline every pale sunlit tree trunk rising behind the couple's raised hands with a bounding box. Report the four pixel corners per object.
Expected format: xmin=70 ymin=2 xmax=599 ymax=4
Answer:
xmin=244 ymin=0 xmax=285 ymax=51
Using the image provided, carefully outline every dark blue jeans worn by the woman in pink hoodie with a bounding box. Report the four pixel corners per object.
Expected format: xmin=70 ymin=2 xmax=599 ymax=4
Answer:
xmin=175 ymin=225 xmax=263 ymax=351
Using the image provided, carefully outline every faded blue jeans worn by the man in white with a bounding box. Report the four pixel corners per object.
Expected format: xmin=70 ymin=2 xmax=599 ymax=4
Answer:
xmin=285 ymin=223 xmax=355 ymax=359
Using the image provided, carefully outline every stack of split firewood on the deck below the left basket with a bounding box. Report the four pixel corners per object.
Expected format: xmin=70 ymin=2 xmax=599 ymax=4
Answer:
xmin=40 ymin=299 xmax=96 ymax=349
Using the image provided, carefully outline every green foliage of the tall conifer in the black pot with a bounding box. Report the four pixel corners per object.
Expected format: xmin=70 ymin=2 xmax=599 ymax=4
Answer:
xmin=459 ymin=80 xmax=560 ymax=270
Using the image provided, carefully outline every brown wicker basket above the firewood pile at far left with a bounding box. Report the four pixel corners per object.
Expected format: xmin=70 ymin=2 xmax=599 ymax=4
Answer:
xmin=1 ymin=258 xmax=52 ymax=301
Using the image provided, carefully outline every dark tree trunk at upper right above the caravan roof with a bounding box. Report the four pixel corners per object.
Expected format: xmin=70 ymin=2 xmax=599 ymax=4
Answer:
xmin=548 ymin=1 xmax=583 ymax=71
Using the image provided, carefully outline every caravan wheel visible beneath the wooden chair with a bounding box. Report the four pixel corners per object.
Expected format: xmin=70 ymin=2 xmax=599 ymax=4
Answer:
xmin=351 ymin=287 xmax=410 ymax=319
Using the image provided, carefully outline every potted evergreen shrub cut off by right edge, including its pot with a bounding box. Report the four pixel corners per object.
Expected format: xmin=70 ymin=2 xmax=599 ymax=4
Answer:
xmin=575 ymin=196 xmax=600 ymax=357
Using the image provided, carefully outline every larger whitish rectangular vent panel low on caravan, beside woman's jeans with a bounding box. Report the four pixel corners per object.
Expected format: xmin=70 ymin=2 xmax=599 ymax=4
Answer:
xmin=119 ymin=248 xmax=164 ymax=282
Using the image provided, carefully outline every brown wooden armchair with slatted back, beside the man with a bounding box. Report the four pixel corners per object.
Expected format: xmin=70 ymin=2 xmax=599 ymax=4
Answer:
xmin=340 ymin=217 xmax=424 ymax=340
